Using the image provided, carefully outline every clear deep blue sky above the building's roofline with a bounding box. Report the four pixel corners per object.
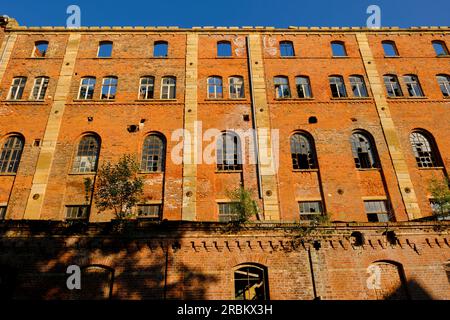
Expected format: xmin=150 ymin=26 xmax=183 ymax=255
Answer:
xmin=0 ymin=0 xmax=450 ymax=27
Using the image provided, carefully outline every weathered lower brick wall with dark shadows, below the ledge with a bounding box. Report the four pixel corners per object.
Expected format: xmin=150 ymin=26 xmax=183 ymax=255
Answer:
xmin=0 ymin=222 xmax=450 ymax=300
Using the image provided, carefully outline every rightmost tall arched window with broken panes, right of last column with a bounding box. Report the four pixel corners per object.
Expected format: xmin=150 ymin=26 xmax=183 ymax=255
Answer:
xmin=410 ymin=131 xmax=440 ymax=168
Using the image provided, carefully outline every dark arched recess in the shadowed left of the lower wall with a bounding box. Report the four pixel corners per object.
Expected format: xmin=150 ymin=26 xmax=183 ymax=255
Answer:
xmin=72 ymin=264 xmax=114 ymax=300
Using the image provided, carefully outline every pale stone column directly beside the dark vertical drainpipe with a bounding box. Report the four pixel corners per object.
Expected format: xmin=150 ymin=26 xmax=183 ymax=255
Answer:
xmin=248 ymin=34 xmax=280 ymax=221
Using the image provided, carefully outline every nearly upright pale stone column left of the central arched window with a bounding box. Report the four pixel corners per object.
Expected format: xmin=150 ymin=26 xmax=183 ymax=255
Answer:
xmin=181 ymin=33 xmax=201 ymax=221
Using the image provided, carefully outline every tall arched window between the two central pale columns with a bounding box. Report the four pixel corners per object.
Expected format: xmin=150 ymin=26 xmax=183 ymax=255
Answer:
xmin=216 ymin=132 xmax=242 ymax=171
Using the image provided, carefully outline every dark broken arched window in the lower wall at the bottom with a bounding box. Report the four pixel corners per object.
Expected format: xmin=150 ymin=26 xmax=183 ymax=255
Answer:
xmin=234 ymin=264 xmax=269 ymax=300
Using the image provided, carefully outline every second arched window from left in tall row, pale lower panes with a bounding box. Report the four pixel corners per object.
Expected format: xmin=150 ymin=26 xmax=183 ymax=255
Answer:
xmin=72 ymin=134 xmax=100 ymax=173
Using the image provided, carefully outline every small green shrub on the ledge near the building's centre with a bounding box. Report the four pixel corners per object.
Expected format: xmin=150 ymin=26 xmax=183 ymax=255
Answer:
xmin=227 ymin=186 xmax=259 ymax=223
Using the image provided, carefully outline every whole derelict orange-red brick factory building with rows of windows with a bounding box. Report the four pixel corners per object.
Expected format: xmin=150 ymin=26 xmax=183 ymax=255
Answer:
xmin=0 ymin=19 xmax=450 ymax=299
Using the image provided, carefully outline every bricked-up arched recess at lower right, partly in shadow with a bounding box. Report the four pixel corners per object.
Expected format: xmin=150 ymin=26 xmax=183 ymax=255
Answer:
xmin=366 ymin=260 xmax=411 ymax=300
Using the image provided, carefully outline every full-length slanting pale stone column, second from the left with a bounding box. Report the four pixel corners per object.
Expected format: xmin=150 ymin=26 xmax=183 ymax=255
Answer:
xmin=24 ymin=33 xmax=81 ymax=219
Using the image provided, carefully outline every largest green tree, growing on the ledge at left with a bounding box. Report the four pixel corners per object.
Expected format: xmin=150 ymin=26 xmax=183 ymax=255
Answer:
xmin=94 ymin=155 xmax=144 ymax=219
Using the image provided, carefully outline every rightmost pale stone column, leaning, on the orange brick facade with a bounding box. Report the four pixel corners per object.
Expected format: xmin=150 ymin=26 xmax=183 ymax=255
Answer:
xmin=356 ymin=32 xmax=421 ymax=220
